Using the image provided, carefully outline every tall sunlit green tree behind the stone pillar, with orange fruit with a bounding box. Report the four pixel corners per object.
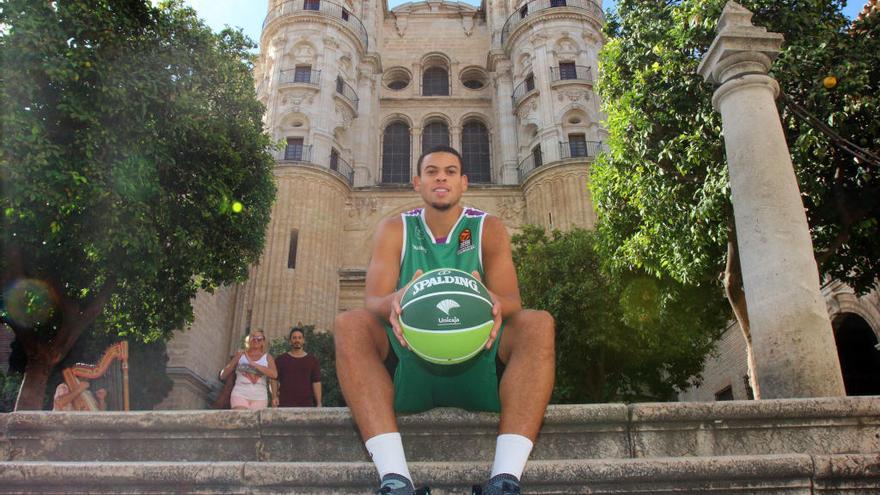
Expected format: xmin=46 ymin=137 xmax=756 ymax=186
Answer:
xmin=591 ymin=0 xmax=880 ymax=392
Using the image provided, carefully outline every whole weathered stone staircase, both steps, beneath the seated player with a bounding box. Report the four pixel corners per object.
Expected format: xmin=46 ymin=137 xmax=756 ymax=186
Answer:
xmin=0 ymin=397 xmax=880 ymax=495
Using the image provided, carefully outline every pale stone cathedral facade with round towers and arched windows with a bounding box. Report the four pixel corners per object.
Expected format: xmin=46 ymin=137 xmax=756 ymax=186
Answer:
xmin=160 ymin=0 xmax=607 ymax=409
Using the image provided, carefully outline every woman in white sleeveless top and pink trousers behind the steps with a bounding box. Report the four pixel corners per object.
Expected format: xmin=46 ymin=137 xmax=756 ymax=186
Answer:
xmin=220 ymin=330 xmax=278 ymax=410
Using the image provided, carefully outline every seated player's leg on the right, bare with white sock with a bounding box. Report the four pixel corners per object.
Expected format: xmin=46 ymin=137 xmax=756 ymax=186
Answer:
xmin=483 ymin=310 xmax=556 ymax=495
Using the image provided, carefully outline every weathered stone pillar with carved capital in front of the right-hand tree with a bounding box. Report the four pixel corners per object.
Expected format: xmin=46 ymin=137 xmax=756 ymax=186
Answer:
xmin=698 ymin=1 xmax=845 ymax=399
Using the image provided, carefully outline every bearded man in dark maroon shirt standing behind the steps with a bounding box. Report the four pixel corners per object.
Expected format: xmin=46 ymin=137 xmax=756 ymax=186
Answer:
xmin=272 ymin=327 xmax=321 ymax=407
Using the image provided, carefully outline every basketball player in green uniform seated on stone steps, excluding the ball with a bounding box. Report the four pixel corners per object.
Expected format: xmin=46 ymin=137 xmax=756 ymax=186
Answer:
xmin=335 ymin=146 xmax=555 ymax=495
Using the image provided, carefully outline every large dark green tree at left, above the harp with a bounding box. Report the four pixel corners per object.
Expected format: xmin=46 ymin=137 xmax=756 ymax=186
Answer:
xmin=0 ymin=0 xmax=275 ymax=409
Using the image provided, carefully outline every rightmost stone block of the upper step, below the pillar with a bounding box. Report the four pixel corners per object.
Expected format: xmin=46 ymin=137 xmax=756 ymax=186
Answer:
xmin=631 ymin=397 xmax=880 ymax=457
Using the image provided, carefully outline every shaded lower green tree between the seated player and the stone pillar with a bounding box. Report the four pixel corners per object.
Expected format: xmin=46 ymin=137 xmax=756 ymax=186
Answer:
xmin=513 ymin=226 xmax=728 ymax=403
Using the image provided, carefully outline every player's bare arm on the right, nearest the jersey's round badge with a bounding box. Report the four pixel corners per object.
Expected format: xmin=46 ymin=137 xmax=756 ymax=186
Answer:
xmin=480 ymin=215 xmax=522 ymax=319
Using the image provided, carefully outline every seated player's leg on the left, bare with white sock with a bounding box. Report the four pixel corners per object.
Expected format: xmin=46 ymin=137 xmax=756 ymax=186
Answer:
xmin=334 ymin=310 xmax=413 ymax=494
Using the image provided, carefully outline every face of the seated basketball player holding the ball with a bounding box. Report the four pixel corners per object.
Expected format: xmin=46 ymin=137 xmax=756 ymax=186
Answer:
xmin=413 ymin=151 xmax=467 ymax=211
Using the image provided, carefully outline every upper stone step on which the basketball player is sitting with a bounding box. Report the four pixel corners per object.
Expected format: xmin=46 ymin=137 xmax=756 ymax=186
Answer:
xmin=0 ymin=397 xmax=880 ymax=462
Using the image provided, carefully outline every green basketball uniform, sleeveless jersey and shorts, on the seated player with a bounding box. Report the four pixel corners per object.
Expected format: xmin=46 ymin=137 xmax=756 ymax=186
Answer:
xmin=386 ymin=208 xmax=501 ymax=412
